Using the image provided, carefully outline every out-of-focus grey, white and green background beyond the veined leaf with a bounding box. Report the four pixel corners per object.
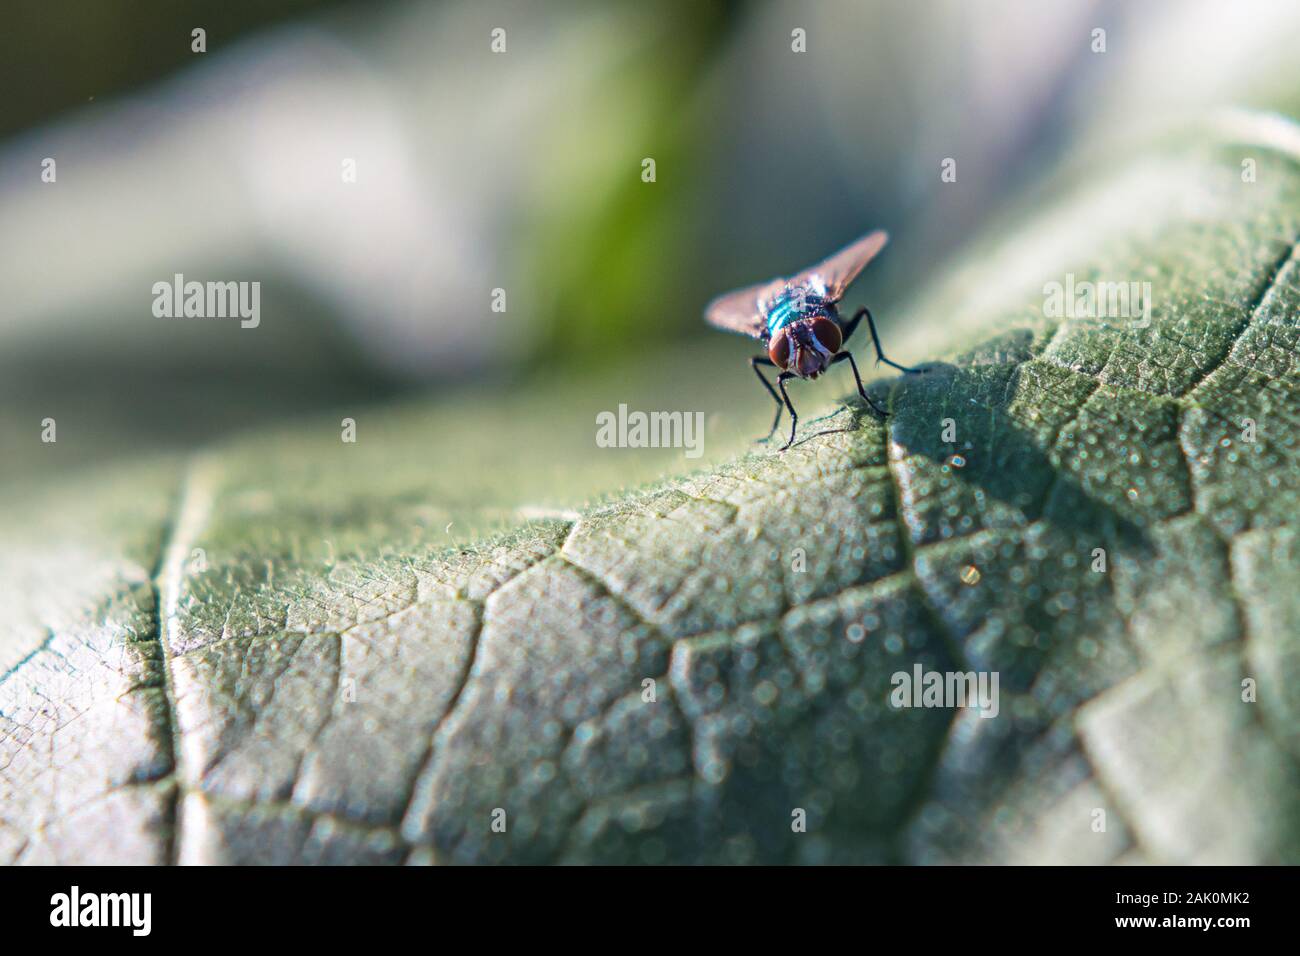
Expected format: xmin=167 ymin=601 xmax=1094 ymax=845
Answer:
xmin=0 ymin=0 xmax=1300 ymax=480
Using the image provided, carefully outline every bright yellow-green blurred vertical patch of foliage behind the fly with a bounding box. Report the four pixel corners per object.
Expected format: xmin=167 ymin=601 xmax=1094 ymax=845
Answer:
xmin=520 ymin=4 xmax=743 ymax=368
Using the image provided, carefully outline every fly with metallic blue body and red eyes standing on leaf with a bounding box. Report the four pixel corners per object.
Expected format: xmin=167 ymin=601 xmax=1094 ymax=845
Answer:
xmin=705 ymin=230 xmax=920 ymax=451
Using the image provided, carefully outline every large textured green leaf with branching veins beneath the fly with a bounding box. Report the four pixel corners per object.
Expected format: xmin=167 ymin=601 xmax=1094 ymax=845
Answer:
xmin=0 ymin=120 xmax=1300 ymax=862
